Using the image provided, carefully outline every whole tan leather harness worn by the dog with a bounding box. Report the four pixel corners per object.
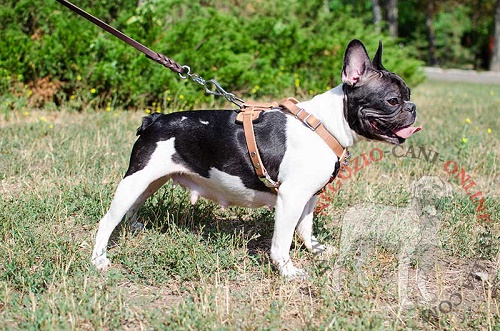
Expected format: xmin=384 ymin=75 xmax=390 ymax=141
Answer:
xmin=236 ymin=98 xmax=350 ymax=194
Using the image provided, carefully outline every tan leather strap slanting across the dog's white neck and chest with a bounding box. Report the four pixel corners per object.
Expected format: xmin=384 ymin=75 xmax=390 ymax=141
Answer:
xmin=279 ymin=98 xmax=347 ymax=164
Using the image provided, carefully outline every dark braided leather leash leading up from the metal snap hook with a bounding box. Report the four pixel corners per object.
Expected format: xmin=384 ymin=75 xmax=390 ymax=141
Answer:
xmin=56 ymin=0 xmax=185 ymax=74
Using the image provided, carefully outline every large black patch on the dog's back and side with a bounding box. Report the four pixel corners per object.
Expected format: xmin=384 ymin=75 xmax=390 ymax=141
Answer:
xmin=125 ymin=110 xmax=286 ymax=192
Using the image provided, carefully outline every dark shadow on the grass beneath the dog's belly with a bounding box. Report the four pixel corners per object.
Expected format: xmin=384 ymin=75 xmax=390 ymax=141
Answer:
xmin=108 ymin=182 xmax=274 ymax=261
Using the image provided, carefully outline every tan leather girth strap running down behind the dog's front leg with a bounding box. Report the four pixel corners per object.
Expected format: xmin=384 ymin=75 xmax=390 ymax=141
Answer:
xmin=236 ymin=103 xmax=280 ymax=194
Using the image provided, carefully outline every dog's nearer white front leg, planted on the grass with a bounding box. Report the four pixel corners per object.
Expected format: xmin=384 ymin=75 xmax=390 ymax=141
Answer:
xmin=271 ymin=184 xmax=310 ymax=279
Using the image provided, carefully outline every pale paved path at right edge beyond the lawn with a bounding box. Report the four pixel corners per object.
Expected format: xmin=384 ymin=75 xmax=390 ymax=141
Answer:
xmin=424 ymin=67 xmax=500 ymax=85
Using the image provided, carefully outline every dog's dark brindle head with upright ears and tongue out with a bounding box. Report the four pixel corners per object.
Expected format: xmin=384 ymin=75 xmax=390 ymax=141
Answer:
xmin=342 ymin=39 xmax=421 ymax=144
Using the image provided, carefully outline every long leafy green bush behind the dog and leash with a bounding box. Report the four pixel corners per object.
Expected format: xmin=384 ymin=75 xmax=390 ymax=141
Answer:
xmin=0 ymin=0 xmax=423 ymax=111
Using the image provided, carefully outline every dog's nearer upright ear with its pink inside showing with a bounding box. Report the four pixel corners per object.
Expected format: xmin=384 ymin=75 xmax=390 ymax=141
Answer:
xmin=342 ymin=39 xmax=372 ymax=86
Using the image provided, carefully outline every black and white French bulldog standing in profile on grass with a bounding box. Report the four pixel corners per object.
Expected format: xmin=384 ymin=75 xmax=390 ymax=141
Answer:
xmin=92 ymin=40 xmax=420 ymax=278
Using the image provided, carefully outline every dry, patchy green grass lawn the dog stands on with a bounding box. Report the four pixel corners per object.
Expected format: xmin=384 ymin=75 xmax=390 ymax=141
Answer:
xmin=0 ymin=82 xmax=500 ymax=330
